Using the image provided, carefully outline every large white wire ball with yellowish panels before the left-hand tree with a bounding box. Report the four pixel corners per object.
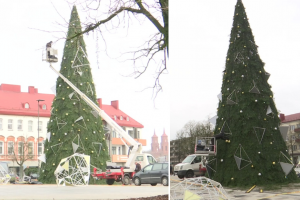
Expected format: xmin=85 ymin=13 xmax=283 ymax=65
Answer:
xmin=54 ymin=153 xmax=90 ymax=186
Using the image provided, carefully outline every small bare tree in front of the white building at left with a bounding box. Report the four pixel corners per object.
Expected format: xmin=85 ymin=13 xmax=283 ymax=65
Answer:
xmin=10 ymin=138 xmax=34 ymax=179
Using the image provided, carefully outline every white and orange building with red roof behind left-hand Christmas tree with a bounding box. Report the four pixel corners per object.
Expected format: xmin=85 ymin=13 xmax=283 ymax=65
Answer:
xmin=0 ymin=84 xmax=147 ymax=173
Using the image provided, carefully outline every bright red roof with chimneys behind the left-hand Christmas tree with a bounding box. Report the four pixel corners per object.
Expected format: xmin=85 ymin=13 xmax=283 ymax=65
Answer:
xmin=0 ymin=84 xmax=144 ymax=128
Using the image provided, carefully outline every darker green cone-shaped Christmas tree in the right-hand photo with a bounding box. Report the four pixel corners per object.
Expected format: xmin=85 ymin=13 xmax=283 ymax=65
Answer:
xmin=213 ymin=0 xmax=297 ymax=186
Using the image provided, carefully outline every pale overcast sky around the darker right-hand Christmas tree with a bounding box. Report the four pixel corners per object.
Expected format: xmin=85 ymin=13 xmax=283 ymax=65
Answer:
xmin=170 ymin=0 xmax=300 ymax=139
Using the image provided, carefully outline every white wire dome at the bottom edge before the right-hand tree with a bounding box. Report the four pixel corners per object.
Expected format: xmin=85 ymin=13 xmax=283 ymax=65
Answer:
xmin=170 ymin=176 xmax=229 ymax=200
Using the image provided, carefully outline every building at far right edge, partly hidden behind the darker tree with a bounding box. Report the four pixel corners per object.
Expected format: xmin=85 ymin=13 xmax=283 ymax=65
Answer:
xmin=280 ymin=113 xmax=300 ymax=164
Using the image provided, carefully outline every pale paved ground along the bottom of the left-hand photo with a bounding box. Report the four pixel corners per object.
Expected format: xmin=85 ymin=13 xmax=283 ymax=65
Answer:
xmin=0 ymin=184 xmax=169 ymax=200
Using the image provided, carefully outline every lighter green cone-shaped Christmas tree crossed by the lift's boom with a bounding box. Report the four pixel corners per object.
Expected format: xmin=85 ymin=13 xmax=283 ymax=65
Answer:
xmin=39 ymin=6 xmax=109 ymax=183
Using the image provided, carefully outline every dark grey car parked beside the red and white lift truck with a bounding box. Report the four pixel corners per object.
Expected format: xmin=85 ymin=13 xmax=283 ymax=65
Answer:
xmin=132 ymin=163 xmax=170 ymax=186
